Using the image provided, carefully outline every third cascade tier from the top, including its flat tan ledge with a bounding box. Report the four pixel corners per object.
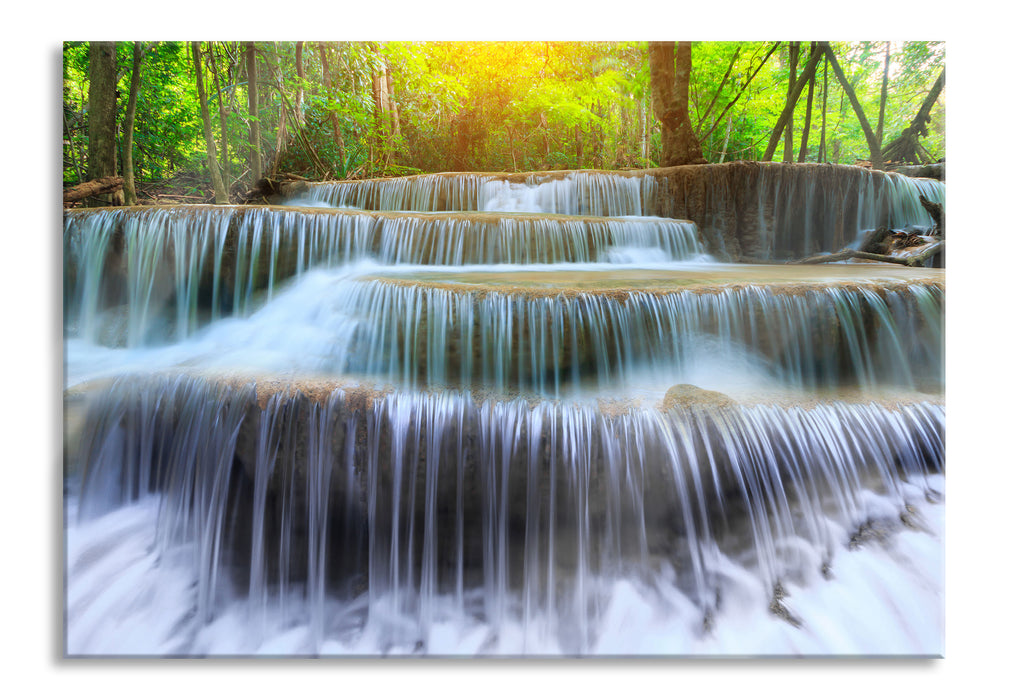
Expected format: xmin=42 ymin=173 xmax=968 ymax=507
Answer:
xmin=339 ymin=265 xmax=944 ymax=395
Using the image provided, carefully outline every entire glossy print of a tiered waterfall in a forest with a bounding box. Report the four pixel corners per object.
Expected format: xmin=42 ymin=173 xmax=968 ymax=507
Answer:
xmin=63 ymin=40 xmax=945 ymax=658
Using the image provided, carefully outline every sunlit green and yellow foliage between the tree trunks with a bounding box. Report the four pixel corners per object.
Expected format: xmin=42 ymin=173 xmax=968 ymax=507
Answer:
xmin=63 ymin=41 xmax=944 ymax=194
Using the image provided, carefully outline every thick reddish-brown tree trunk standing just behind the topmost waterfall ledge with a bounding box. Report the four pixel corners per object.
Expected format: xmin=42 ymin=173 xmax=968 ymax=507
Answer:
xmin=648 ymin=41 xmax=707 ymax=167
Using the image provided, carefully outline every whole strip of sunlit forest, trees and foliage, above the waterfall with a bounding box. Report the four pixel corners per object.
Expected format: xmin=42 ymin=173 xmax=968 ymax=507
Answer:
xmin=63 ymin=41 xmax=945 ymax=204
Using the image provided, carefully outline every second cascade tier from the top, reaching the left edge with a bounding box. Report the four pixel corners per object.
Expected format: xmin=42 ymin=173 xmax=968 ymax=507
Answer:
xmin=64 ymin=206 xmax=703 ymax=345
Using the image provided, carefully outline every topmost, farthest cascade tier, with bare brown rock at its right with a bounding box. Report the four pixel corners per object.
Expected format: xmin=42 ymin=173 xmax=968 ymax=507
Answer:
xmin=286 ymin=162 xmax=945 ymax=260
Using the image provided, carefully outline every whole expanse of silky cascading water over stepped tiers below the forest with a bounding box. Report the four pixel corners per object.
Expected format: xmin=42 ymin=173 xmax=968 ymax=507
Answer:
xmin=65 ymin=163 xmax=945 ymax=656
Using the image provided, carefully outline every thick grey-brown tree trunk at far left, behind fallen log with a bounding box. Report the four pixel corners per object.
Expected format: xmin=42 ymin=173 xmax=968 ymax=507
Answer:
xmin=88 ymin=41 xmax=122 ymax=206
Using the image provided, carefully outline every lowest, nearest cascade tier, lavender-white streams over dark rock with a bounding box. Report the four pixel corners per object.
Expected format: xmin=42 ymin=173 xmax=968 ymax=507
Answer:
xmin=71 ymin=376 xmax=944 ymax=653
